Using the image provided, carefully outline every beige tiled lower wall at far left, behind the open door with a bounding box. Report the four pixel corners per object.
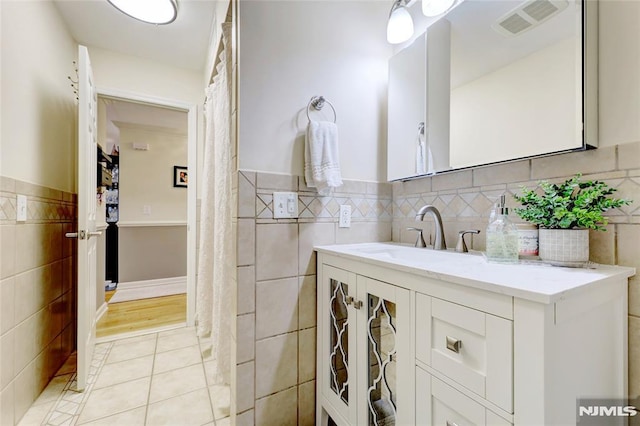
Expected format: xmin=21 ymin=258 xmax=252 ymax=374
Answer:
xmin=0 ymin=177 xmax=77 ymax=425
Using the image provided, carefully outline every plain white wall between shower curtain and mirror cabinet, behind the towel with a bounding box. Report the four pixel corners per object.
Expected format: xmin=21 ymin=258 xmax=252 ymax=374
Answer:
xmin=239 ymin=1 xmax=392 ymax=181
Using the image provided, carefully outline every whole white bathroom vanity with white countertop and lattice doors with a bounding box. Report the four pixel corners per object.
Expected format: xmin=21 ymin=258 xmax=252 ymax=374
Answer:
xmin=316 ymin=243 xmax=635 ymax=426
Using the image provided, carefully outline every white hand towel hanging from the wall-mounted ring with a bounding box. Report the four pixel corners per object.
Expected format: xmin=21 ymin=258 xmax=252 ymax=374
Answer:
xmin=304 ymin=121 xmax=342 ymax=195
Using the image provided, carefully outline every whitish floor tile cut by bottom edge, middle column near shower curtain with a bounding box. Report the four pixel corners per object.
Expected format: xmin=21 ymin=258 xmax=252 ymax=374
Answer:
xmin=147 ymin=389 xmax=213 ymax=426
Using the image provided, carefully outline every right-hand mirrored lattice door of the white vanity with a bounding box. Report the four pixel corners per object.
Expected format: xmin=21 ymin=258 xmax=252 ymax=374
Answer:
xmin=357 ymin=275 xmax=415 ymax=426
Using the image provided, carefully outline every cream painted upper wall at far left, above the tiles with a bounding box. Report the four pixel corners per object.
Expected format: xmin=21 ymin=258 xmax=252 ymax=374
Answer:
xmin=0 ymin=0 xmax=77 ymax=192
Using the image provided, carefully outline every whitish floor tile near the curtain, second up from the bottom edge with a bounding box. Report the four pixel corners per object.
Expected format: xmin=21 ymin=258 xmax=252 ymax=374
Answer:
xmin=149 ymin=364 xmax=207 ymax=403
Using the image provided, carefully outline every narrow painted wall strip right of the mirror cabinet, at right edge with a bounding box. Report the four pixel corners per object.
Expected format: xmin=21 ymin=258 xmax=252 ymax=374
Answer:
xmin=598 ymin=0 xmax=640 ymax=147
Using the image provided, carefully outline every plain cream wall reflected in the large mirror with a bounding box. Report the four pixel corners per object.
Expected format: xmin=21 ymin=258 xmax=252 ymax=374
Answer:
xmin=449 ymin=39 xmax=582 ymax=168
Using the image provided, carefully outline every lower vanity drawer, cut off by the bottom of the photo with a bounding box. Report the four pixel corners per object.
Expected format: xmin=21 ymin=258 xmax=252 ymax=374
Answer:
xmin=416 ymin=367 xmax=511 ymax=426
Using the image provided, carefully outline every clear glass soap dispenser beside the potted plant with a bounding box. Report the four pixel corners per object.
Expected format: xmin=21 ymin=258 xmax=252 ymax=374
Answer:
xmin=486 ymin=195 xmax=518 ymax=263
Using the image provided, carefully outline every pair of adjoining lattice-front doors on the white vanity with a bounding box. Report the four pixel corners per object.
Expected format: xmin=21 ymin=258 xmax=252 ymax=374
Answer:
xmin=317 ymin=264 xmax=414 ymax=425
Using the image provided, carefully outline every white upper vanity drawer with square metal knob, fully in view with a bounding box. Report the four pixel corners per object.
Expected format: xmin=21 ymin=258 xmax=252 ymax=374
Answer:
xmin=416 ymin=294 xmax=513 ymax=413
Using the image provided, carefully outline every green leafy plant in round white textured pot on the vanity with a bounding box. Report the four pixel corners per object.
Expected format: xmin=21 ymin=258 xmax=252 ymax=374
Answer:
xmin=514 ymin=174 xmax=631 ymax=265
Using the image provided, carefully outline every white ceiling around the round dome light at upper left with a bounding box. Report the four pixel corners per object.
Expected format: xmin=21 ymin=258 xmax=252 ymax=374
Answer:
xmin=53 ymin=0 xmax=216 ymax=72
